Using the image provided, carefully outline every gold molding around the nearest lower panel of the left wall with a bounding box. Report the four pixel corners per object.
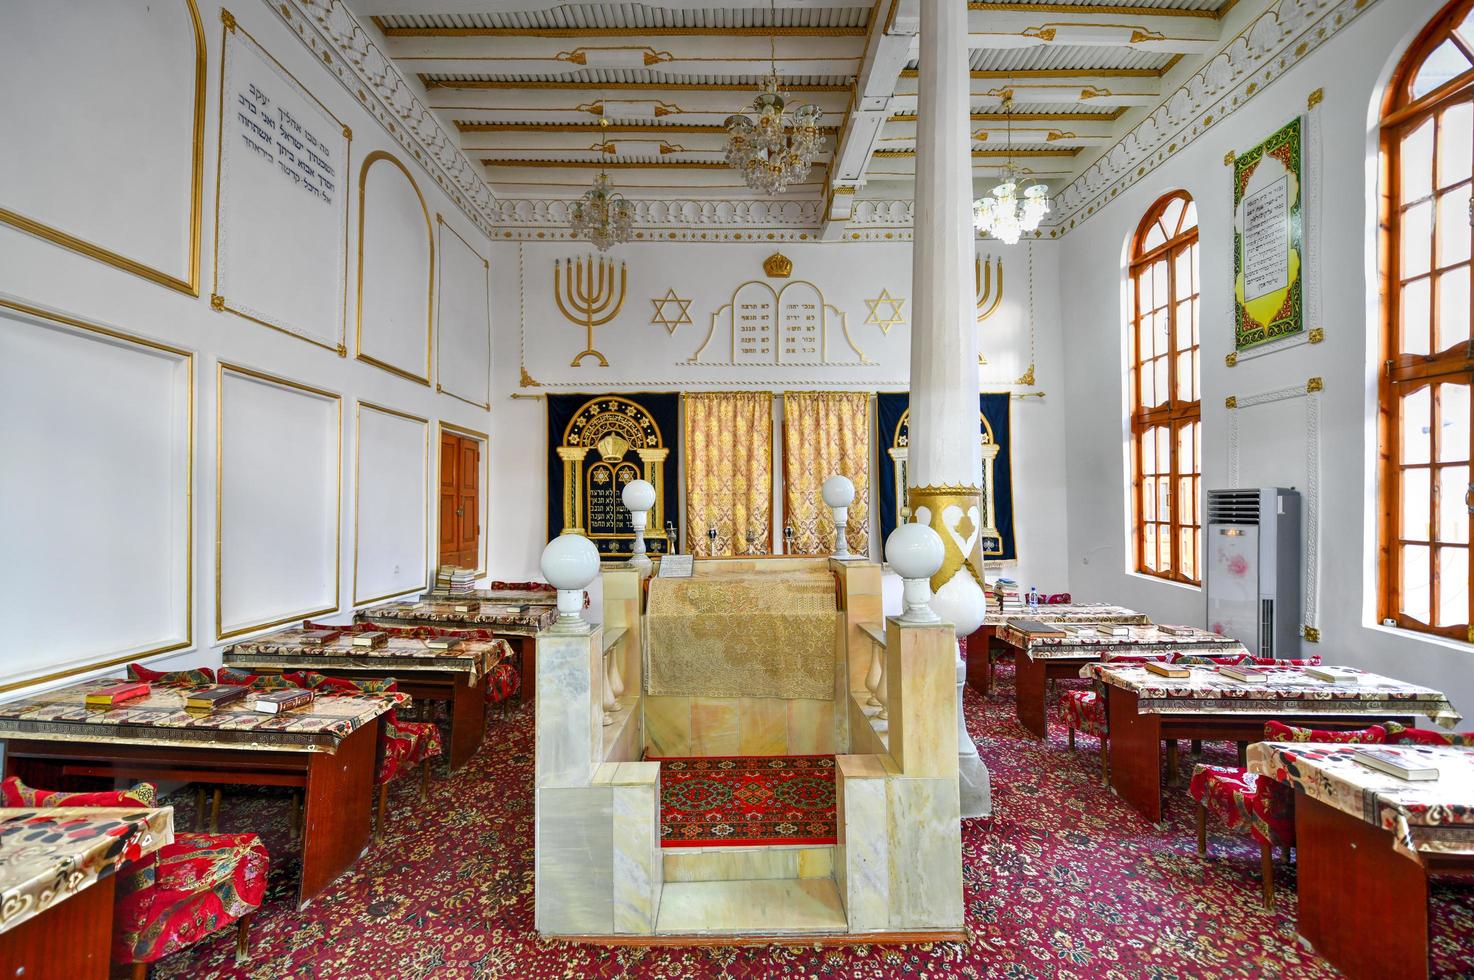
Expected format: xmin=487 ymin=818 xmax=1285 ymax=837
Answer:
xmin=0 ymin=296 xmax=195 ymax=694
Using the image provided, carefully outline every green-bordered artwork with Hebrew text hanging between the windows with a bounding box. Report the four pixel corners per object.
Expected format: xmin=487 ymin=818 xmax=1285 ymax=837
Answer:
xmin=1234 ymin=116 xmax=1304 ymax=352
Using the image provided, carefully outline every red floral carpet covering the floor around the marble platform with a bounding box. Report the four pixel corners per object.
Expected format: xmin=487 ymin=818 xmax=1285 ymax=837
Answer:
xmin=155 ymin=668 xmax=1474 ymax=980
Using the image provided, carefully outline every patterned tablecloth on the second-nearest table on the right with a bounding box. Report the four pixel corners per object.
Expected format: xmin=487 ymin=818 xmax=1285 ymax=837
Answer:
xmin=1080 ymin=663 xmax=1461 ymax=728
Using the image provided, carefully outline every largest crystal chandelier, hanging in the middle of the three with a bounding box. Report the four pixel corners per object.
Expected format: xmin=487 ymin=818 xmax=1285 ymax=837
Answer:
xmin=727 ymin=0 xmax=824 ymax=195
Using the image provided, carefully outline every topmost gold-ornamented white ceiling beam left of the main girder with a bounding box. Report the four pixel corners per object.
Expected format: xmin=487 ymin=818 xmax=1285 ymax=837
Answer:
xmin=385 ymin=35 xmax=862 ymax=75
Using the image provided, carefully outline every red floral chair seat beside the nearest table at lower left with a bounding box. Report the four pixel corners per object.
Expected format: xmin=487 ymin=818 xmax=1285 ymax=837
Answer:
xmin=112 ymin=834 xmax=271 ymax=962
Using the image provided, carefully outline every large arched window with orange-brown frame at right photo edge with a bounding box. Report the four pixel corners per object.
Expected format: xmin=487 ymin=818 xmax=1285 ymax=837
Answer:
xmin=1378 ymin=0 xmax=1474 ymax=641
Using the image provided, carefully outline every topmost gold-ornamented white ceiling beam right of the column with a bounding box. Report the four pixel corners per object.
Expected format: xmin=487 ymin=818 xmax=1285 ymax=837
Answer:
xmin=967 ymin=3 xmax=1222 ymax=55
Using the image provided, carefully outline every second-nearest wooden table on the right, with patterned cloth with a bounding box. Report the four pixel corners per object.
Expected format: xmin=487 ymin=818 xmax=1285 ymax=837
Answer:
xmin=1080 ymin=663 xmax=1459 ymax=824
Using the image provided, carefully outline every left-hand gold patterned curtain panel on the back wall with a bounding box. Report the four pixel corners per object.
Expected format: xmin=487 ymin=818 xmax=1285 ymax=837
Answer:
xmin=681 ymin=392 xmax=772 ymax=557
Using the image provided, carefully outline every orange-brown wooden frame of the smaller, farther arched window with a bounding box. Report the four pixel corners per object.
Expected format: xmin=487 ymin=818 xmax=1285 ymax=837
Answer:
xmin=1128 ymin=190 xmax=1203 ymax=587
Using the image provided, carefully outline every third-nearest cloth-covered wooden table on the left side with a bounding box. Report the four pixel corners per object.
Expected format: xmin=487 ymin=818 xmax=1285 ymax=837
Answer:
xmin=221 ymin=628 xmax=511 ymax=769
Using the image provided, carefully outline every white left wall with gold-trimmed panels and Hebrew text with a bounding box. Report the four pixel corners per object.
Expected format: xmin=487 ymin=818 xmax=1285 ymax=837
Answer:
xmin=0 ymin=0 xmax=491 ymax=697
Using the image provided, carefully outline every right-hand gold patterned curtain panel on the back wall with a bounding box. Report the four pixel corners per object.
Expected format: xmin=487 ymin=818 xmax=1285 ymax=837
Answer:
xmin=783 ymin=392 xmax=870 ymax=556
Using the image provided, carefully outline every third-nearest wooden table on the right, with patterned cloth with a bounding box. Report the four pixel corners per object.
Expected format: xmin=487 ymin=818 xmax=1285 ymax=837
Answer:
xmin=998 ymin=620 xmax=1248 ymax=738
